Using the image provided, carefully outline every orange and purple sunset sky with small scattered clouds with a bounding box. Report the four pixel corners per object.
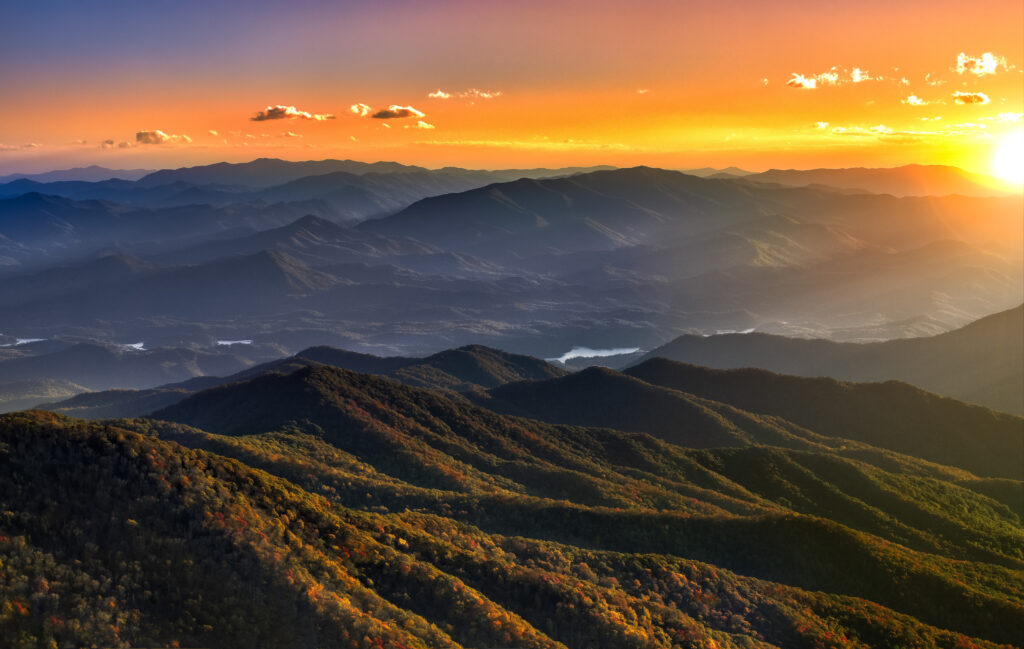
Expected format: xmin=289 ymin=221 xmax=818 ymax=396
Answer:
xmin=0 ymin=0 xmax=1024 ymax=176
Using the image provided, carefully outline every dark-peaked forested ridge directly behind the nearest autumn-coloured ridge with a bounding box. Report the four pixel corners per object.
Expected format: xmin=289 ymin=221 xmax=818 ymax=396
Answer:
xmin=130 ymin=366 xmax=1019 ymax=646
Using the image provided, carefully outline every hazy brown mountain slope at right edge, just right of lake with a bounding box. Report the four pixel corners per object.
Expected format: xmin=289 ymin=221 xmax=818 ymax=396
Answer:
xmin=646 ymin=305 xmax=1024 ymax=415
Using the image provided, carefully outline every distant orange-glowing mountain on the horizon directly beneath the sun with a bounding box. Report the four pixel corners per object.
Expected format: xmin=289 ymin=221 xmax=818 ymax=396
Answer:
xmin=745 ymin=165 xmax=1005 ymax=197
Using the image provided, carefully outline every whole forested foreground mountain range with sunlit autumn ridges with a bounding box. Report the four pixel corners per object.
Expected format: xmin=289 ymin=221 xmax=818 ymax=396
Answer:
xmin=0 ymin=350 xmax=1024 ymax=649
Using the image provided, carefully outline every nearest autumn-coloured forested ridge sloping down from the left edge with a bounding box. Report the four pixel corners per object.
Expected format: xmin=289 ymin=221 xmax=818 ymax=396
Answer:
xmin=6 ymin=401 xmax=1020 ymax=649
